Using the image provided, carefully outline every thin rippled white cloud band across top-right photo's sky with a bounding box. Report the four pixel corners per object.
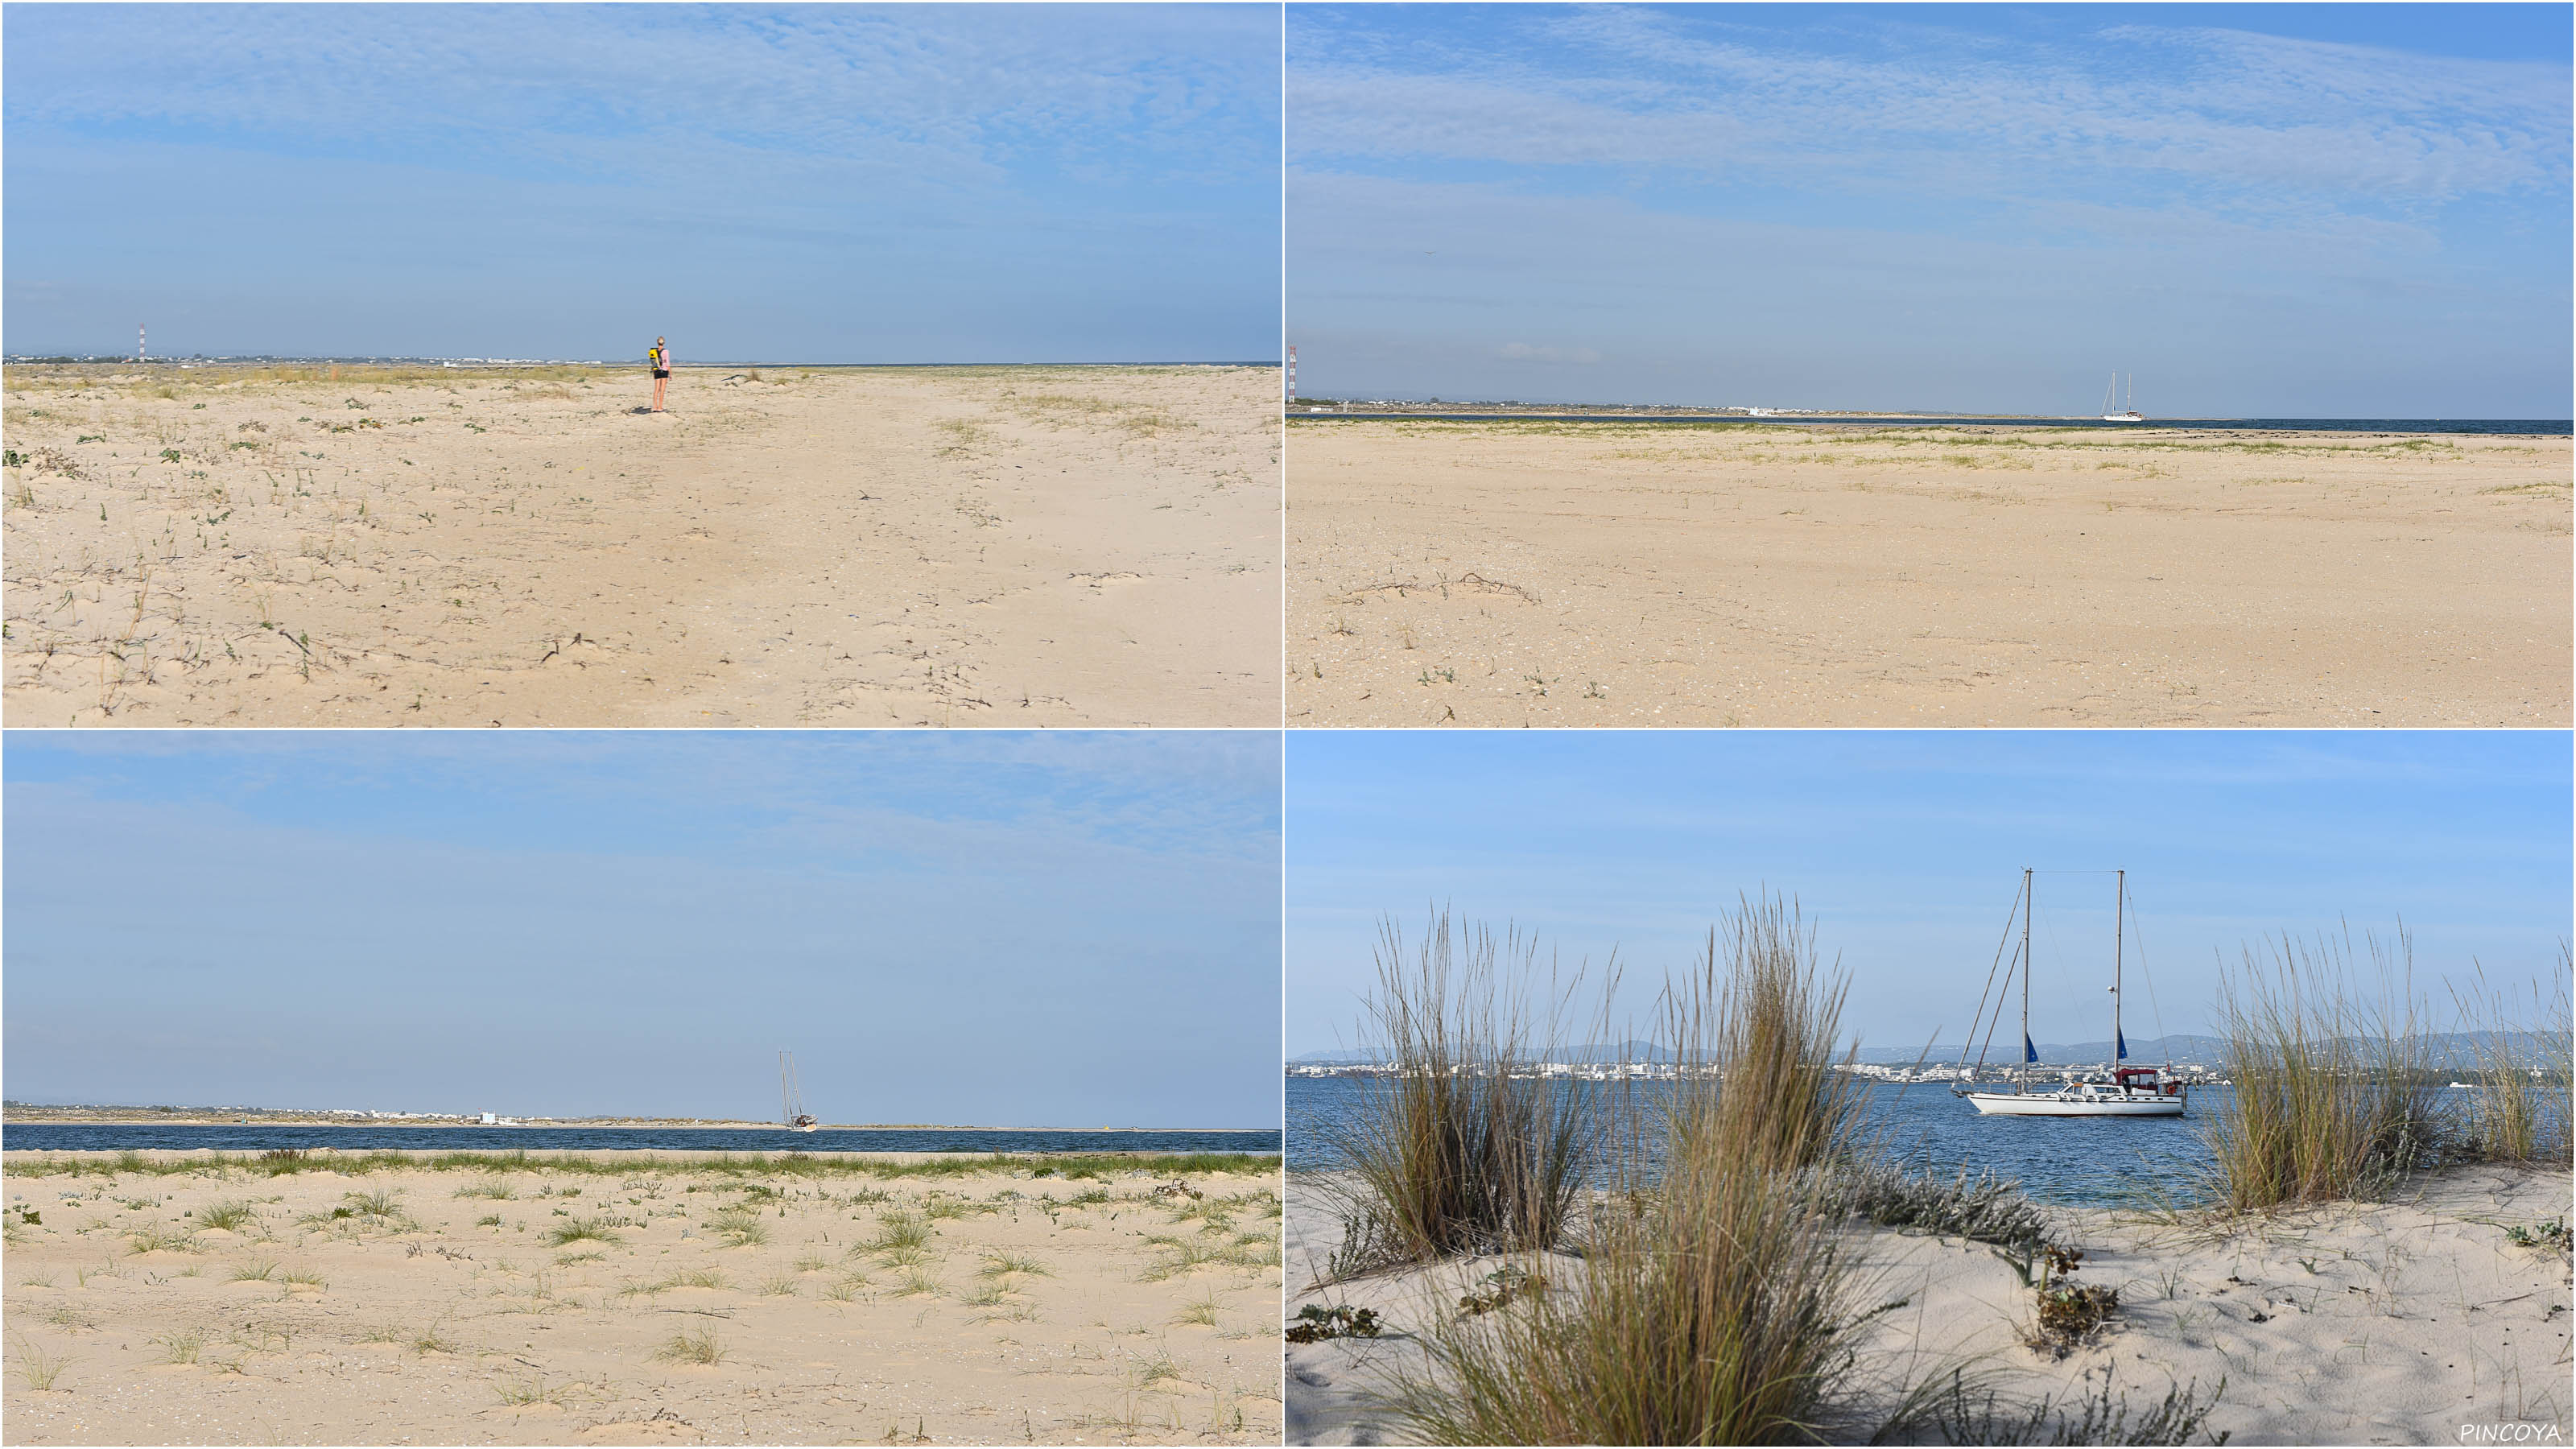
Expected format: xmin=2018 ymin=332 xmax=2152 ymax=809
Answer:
xmin=1290 ymin=8 xmax=2568 ymax=212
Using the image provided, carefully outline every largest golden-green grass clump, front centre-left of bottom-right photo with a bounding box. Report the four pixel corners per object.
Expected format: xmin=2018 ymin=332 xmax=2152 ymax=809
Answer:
xmin=1391 ymin=900 xmax=1870 ymax=1444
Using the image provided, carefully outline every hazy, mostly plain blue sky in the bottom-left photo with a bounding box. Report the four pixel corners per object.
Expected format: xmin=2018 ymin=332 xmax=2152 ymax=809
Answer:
xmin=0 ymin=729 xmax=1280 ymax=1127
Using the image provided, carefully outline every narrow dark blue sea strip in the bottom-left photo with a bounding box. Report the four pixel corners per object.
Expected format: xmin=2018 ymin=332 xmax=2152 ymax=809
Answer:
xmin=0 ymin=1121 xmax=1280 ymax=1153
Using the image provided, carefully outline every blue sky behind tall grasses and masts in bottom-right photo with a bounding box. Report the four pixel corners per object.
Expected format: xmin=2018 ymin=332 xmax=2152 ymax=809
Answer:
xmin=1288 ymin=729 xmax=2576 ymax=1055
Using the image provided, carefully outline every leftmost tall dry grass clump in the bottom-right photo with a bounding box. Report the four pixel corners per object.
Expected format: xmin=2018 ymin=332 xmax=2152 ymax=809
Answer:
xmin=1335 ymin=913 xmax=1615 ymax=1274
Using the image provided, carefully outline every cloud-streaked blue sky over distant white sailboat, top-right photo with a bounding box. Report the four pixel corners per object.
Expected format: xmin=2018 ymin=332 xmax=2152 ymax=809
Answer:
xmin=1288 ymin=5 xmax=2576 ymax=418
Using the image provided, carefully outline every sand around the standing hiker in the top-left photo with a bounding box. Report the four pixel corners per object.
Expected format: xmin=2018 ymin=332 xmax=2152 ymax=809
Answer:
xmin=5 ymin=366 xmax=1280 ymax=727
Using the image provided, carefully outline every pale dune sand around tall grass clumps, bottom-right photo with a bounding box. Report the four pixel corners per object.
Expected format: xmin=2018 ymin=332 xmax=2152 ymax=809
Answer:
xmin=1288 ymin=1168 xmax=2576 ymax=1444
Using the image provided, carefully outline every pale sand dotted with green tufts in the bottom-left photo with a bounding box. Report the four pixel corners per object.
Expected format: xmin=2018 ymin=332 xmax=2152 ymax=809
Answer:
xmin=0 ymin=1153 xmax=1280 ymax=1444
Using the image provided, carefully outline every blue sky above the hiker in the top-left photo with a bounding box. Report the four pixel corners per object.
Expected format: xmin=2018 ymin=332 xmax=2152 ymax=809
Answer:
xmin=0 ymin=5 xmax=1280 ymax=361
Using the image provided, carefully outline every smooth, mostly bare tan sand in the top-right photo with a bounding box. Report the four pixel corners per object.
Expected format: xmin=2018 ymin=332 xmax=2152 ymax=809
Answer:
xmin=1288 ymin=420 xmax=2571 ymax=729
